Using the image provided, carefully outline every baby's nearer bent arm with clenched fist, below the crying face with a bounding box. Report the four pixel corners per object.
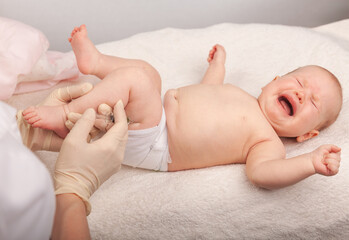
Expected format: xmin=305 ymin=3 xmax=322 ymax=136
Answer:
xmin=246 ymin=142 xmax=341 ymax=189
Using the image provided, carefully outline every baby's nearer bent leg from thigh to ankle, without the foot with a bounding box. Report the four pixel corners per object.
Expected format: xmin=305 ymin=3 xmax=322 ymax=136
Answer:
xmin=68 ymin=67 xmax=162 ymax=129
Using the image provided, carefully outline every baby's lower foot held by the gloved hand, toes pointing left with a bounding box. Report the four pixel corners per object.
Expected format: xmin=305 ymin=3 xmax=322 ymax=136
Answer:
xmin=22 ymin=105 xmax=69 ymax=138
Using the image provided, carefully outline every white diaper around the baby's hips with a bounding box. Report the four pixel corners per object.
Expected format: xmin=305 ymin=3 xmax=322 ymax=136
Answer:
xmin=123 ymin=109 xmax=171 ymax=172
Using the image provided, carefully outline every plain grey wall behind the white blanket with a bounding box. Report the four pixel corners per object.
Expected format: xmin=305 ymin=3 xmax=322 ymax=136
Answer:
xmin=0 ymin=0 xmax=349 ymax=51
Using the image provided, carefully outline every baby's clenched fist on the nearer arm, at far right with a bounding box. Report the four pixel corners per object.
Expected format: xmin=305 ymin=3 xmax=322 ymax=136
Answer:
xmin=311 ymin=144 xmax=341 ymax=176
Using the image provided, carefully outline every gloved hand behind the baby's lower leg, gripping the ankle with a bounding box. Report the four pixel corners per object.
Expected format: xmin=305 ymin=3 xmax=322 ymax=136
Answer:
xmin=17 ymin=83 xmax=93 ymax=152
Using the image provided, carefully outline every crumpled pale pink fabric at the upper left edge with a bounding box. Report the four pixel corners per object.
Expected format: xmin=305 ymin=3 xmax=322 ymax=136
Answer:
xmin=0 ymin=17 xmax=79 ymax=100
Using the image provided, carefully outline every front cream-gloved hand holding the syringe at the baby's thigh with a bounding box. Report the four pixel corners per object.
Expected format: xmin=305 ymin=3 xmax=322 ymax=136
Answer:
xmin=54 ymin=101 xmax=128 ymax=215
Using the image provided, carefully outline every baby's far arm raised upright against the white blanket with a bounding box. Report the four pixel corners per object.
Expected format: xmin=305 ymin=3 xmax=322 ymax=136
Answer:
xmin=201 ymin=44 xmax=225 ymax=84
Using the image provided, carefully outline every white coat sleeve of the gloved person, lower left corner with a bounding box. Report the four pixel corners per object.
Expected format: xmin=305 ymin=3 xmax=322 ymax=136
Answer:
xmin=0 ymin=102 xmax=55 ymax=240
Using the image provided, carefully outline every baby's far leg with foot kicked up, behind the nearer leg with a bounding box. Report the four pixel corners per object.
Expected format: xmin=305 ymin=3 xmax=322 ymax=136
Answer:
xmin=69 ymin=25 xmax=161 ymax=88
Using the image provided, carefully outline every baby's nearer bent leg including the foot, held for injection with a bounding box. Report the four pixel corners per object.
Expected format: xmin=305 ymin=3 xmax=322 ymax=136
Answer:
xmin=23 ymin=67 xmax=162 ymax=138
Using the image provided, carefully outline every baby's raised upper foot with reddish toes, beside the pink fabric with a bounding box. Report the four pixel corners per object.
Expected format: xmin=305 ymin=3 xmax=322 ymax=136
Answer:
xmin=68 ymin=25 xmax=101 ymax=74
